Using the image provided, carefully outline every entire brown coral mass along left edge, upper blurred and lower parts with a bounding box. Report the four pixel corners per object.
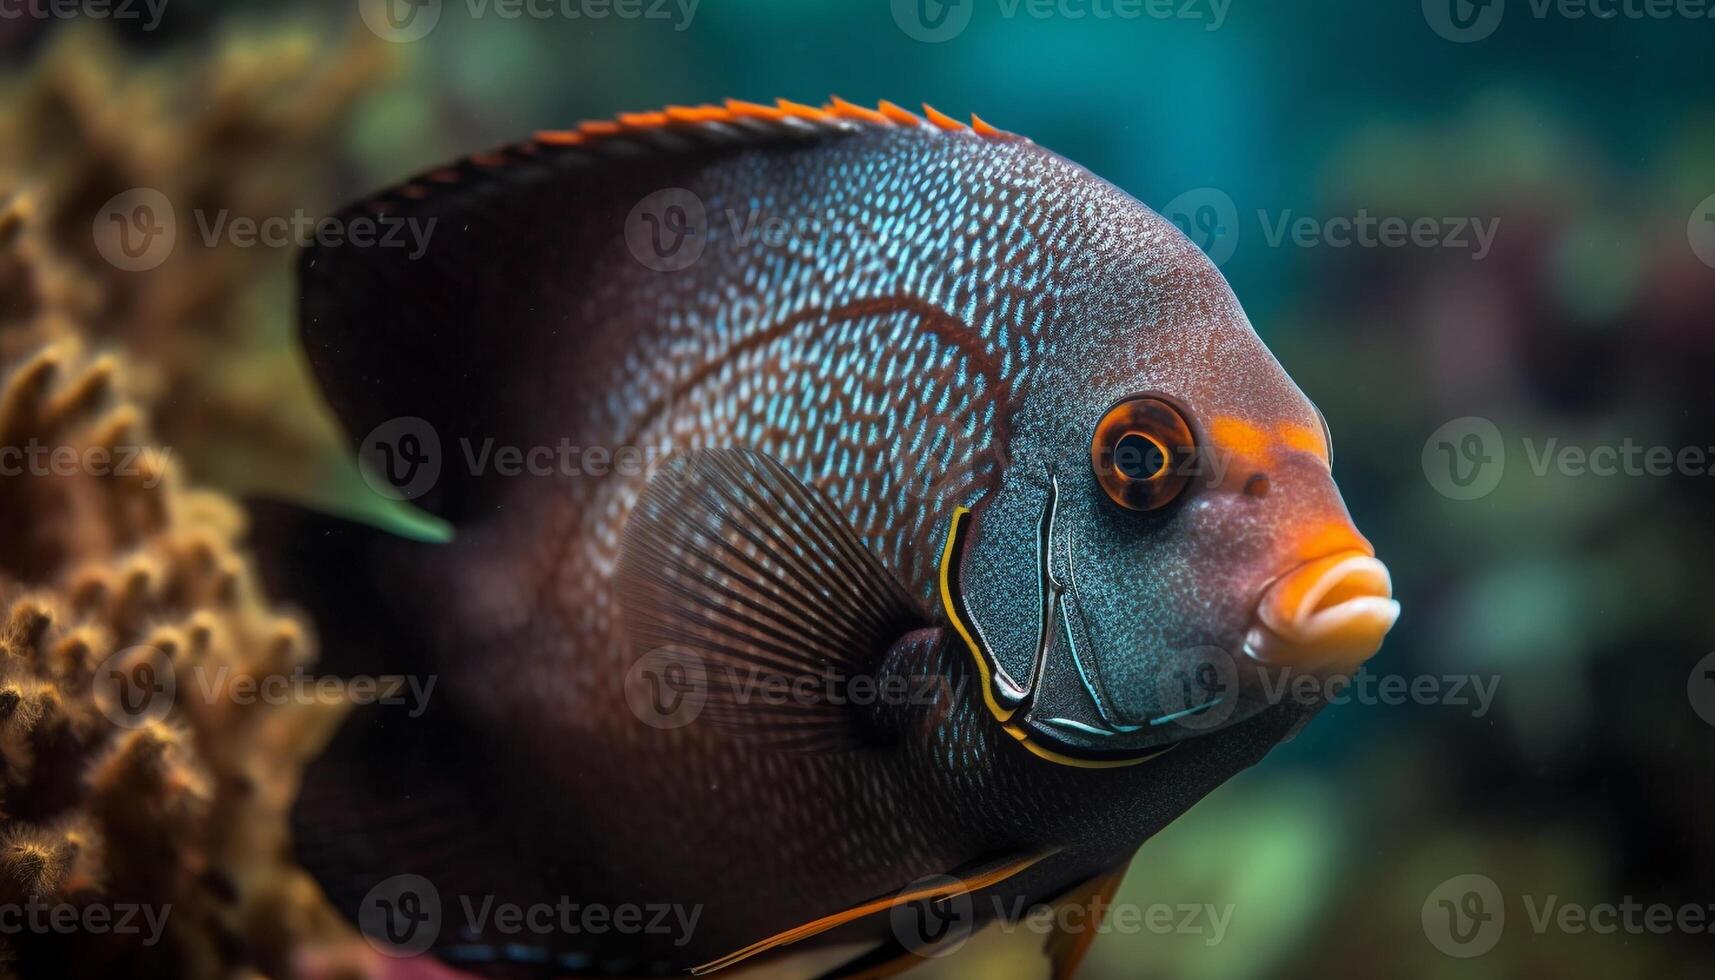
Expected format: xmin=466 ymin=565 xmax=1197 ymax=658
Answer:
xmin=0 ymin=24 xmax=392 ymax=977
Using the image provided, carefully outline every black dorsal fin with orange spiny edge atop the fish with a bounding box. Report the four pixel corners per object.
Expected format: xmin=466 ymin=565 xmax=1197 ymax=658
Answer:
xmin=300 ymin=98 xmax=1015 ymax=522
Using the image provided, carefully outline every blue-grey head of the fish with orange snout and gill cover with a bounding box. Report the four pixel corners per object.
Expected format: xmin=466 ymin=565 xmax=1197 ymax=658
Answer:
xmin=943 ymin=183 xmax=1399 ymax=765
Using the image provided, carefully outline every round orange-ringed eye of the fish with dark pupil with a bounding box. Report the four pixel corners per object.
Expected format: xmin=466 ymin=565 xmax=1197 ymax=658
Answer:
xmin=1089 ymin=395 xmax=1197 ymax=510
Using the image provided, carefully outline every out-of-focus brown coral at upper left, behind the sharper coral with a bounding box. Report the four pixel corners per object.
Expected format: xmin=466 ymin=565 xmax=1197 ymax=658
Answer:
xmin=0 ymin=24 xmax=389 ymax=496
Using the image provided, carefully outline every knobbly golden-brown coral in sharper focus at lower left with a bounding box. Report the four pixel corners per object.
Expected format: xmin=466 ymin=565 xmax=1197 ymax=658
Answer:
xmin=0 ymin=192 xmax=350 ymax=977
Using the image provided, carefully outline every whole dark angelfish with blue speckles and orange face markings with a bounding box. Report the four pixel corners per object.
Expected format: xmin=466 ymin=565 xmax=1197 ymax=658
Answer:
xmin=274 ymin=100 xmax=1398 ymax=977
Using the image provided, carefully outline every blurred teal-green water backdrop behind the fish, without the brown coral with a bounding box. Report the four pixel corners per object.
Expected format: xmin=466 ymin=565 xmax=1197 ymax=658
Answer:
xmin=0 ymin=0 xmax=1715 ymax=978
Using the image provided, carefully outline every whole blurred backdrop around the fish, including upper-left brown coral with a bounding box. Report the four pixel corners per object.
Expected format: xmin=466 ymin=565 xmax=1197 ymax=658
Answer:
xmin=0 ymin=0 xmax=1715 ymax=980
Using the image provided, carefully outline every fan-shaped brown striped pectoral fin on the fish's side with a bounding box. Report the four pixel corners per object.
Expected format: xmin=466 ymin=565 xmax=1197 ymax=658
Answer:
xmin=617 ymin=450 xmax=928 ymax=750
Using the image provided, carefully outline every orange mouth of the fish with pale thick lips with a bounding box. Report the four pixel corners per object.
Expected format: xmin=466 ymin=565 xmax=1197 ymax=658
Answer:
xmin=1245 ymin=549 xmax=1399 ymax=671
